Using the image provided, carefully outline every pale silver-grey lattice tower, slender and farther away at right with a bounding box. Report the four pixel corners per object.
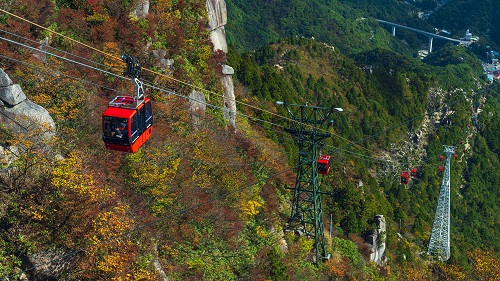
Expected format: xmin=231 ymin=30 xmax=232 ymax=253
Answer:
xmin=427 ymin=145 xmax=456 ymax=261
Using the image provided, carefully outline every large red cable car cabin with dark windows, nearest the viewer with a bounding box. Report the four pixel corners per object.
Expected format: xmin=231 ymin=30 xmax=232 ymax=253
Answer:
xmin=102 ymin=96 xmax=153 ymax=153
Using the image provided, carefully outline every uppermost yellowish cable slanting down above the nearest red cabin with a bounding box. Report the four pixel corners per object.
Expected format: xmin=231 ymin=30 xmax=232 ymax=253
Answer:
xmin=0 ymin=8 xmax=366 ymax=149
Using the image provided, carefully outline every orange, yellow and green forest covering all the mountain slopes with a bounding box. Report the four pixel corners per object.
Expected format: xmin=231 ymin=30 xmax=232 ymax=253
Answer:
xmin=0 ymin=0 xmax=500 ymax=280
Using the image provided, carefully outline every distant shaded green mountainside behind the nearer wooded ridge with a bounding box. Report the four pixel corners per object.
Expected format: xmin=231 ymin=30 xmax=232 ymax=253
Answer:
xmin=226 ymin=0 xmax=500 ymax=55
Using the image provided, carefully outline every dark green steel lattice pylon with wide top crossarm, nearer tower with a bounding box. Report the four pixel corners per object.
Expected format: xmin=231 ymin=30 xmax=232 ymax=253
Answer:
xmin=277 ymin=102 xmax=342 ymax=265
